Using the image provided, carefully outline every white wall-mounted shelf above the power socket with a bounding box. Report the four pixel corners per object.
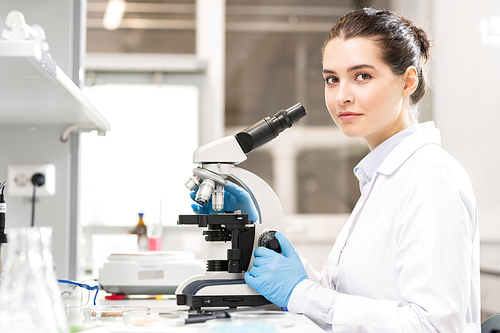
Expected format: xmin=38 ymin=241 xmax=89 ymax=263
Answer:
xmin=0 ymin=40 xmax=110 ymax=139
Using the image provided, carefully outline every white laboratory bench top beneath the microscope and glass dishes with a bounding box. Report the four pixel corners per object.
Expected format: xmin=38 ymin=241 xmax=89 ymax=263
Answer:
xmin=67 ymin=292 xmax=324 ymax=333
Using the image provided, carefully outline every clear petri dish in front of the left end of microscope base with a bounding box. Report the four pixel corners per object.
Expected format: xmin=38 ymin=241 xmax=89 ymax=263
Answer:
xmin=123 ymin=311 xmax=189 ymax=327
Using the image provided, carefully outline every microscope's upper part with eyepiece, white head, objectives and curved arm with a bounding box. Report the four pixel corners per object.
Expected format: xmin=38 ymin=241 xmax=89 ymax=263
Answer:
xmin=186 ymin=103 xmax=306 ymax=248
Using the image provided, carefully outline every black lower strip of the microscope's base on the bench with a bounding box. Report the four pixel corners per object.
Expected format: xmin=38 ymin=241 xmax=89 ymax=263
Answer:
xmin=177 ymin=295 xmax=271 ymax=310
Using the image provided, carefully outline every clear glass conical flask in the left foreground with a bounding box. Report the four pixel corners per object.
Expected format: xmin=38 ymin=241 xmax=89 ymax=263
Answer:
xmin=0 ymin=227 xmax=69 ymax=333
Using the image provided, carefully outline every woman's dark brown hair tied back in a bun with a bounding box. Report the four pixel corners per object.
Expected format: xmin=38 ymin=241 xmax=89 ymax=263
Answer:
xmin=323 ymin=8 xmax=432 ymax=104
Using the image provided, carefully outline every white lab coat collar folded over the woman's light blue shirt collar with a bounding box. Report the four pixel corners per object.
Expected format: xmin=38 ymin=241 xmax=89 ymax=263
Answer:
xmin=377 ymin=121 xmax=441 ymax=175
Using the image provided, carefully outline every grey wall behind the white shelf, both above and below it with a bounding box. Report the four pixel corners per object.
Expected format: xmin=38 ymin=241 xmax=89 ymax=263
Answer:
xmin=0 ymin=0 xmax=77 ymax=278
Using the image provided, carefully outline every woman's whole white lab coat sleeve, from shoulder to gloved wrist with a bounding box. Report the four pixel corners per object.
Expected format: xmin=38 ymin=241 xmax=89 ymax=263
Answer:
xmin=289 ymin=157 xmax=477 ymax=333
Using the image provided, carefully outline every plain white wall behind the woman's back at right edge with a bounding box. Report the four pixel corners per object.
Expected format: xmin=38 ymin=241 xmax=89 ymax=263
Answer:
xmin=431 ymin=0 xmax=500 ymax=241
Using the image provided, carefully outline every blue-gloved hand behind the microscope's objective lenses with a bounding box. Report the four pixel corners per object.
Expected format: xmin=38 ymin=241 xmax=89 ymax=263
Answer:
xmin=191 ymin=181 xmax=259 ymax=223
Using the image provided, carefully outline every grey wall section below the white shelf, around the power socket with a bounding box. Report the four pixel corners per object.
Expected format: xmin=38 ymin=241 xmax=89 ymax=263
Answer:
xmin=0 ymin=125 xmax=69 ymax=278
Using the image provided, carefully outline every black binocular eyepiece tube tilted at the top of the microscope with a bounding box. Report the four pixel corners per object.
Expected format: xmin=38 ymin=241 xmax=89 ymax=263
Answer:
xmin=236 ymin=103 xmax=307 ymax=154
